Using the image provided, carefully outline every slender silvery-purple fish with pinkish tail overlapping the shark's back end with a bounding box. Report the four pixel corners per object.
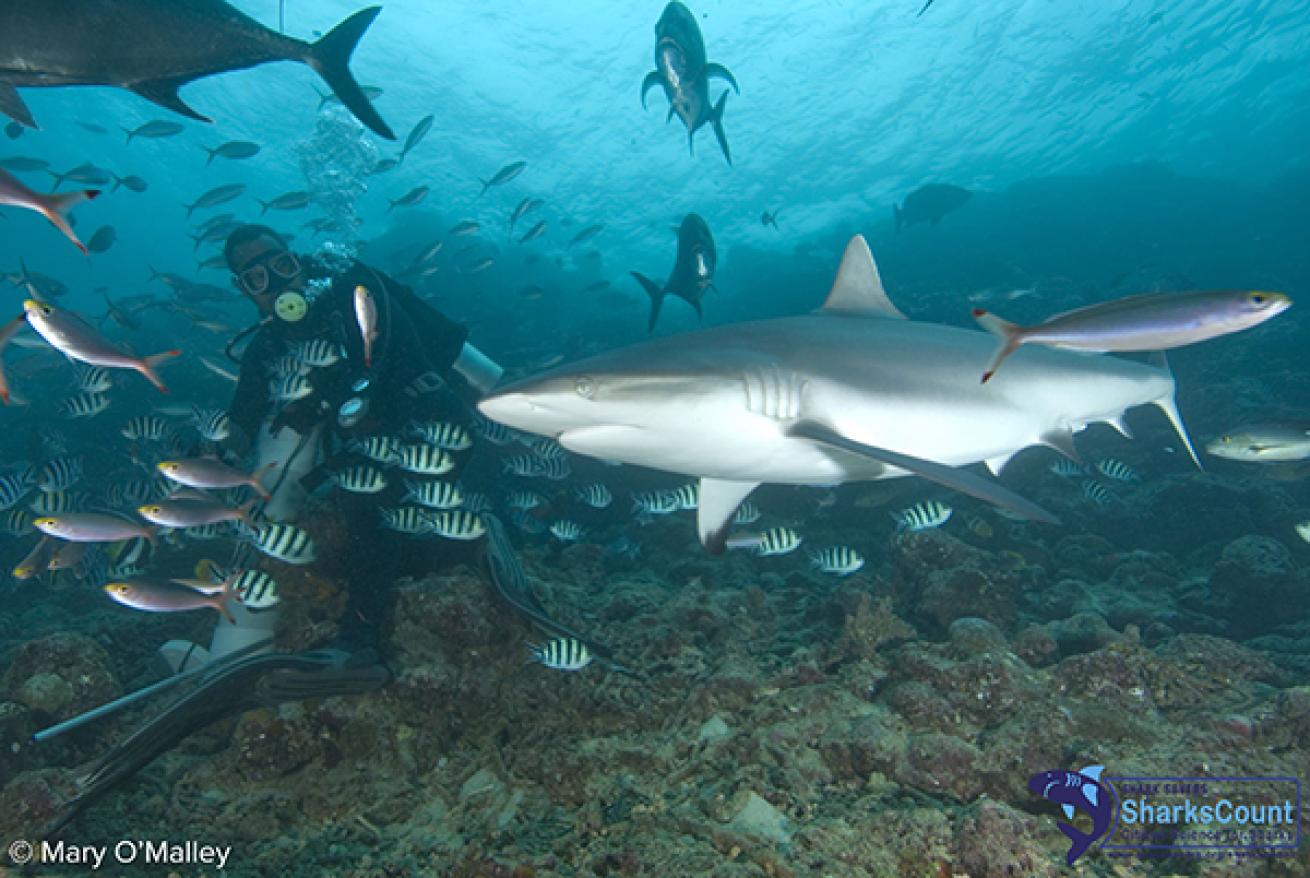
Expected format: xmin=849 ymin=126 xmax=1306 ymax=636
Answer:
xmin=973 ymin=290 xmax=1292 ymax=384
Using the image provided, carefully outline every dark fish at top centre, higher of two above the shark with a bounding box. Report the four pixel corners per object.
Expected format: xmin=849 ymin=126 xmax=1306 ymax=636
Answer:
xmin=642 ymin=0 xmax=741 ymax=165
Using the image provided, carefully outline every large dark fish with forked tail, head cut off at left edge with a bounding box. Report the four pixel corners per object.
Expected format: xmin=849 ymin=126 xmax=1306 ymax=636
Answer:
xmin=0 ymin=0 xmax=396 ymax=140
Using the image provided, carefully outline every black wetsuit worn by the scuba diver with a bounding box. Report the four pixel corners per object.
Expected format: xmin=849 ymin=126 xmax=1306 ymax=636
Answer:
xmin=229 ymin=262 xmax=473 ymax=650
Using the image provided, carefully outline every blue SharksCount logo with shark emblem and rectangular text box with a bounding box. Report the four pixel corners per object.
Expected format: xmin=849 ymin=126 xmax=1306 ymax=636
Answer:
xmin=1028 ymin=765 xmax=1301 ymax=866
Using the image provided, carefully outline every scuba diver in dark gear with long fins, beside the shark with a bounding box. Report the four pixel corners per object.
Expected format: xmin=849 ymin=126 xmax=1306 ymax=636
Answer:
xmin=35 ymin=225 xmax=510 ymax=833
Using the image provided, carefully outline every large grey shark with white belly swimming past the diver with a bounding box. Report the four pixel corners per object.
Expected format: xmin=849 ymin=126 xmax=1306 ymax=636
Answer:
xmin=478 ymin=236 xmax=1195 ymax=552
